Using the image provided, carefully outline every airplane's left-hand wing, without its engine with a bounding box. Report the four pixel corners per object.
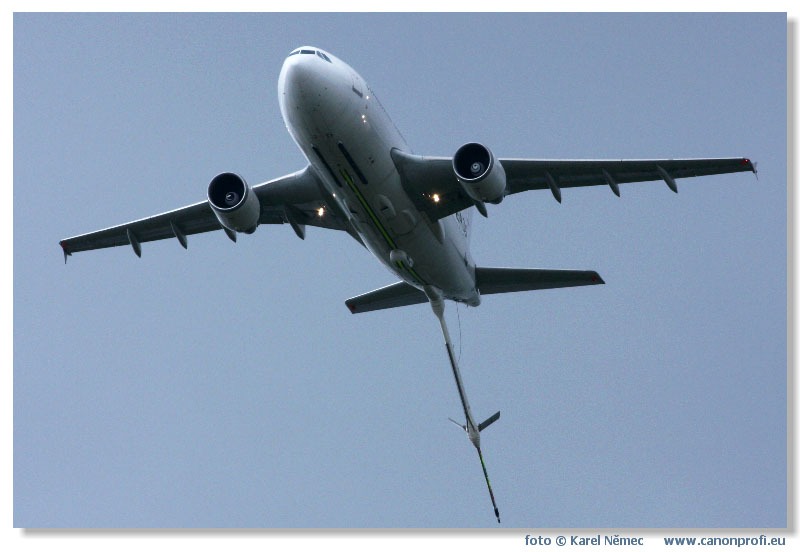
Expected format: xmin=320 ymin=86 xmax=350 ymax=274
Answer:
xmin=59 ymin=167 xmax=346 ymax=261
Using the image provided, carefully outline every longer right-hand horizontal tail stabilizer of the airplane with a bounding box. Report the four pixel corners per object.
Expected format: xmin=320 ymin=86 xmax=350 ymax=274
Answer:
xmin=475 ymin=267 xmax=605 ymax=295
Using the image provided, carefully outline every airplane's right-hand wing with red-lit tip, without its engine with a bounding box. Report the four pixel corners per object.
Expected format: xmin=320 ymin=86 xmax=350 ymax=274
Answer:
xmin=392 ymin=150 xmax=756 ymax=221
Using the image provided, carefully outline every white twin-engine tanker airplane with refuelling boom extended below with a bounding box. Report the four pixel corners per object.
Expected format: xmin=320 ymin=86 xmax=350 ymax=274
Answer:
xmin=59 ymin=46 xmax=756 ymax=523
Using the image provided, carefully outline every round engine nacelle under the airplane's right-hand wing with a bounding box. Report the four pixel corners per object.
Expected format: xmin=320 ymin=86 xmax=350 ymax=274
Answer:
xmin=453 ymin=142 xmax=506 ymax=203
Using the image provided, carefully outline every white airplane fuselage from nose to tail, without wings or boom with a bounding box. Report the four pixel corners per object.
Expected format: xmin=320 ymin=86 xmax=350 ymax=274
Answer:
xmin=278 ymin=47 xmax=480 ymax=306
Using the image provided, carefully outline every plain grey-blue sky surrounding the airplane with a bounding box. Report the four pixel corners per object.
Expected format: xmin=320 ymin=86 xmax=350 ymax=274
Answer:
xmin=13 ymin=13 xmax=787 ymax=528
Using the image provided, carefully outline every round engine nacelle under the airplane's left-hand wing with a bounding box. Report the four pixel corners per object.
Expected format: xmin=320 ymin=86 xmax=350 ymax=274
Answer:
xmin=208 ymin=173 xmax=261 ymax=234
